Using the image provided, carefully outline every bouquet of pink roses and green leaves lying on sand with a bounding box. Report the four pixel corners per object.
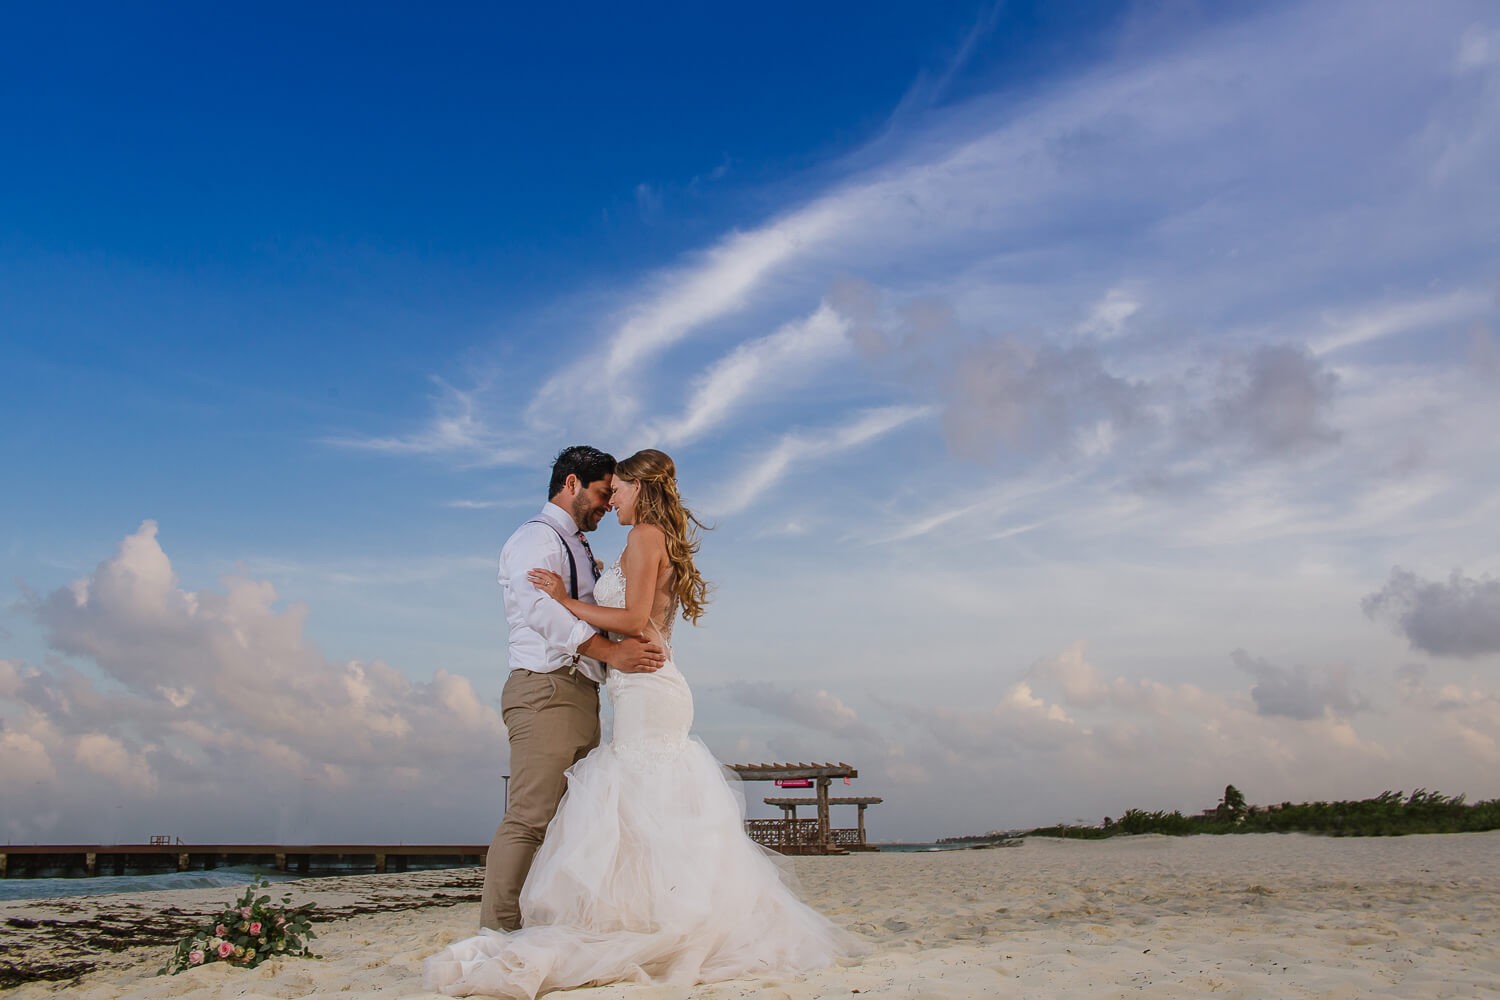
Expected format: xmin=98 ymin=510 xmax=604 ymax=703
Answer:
xmin=158 ymin=879 xmax=318 ymax=976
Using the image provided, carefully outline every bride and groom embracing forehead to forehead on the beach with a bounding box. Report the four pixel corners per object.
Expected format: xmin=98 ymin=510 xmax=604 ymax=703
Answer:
xmin=426 ymin=447 xmax=857 ymax=1000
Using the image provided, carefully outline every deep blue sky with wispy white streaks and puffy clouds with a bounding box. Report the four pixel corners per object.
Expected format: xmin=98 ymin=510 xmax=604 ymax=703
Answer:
xmin=0 ymin=1 xmax=1500 ymax=841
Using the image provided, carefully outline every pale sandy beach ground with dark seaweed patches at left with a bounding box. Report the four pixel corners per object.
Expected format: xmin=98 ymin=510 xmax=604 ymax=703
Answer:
xmin=0 ymin=832 xmax=1500 ymax=1000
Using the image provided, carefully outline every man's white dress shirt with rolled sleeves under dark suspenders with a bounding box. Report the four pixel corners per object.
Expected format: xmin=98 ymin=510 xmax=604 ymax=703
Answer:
xmin=500 ymin=502 xmax=605 ymax=684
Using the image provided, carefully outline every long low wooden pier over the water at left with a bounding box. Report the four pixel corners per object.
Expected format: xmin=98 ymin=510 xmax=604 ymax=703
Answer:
xmin=0 ymin=838 xmax=489 ymax=879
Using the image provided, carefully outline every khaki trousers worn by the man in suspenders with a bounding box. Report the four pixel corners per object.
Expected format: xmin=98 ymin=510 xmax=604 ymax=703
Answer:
xmin=479 ymin=667 xmax=599 ymax=931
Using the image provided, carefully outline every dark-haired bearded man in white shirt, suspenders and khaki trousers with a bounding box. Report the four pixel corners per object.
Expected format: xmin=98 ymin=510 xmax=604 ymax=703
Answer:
xmin=479 ymin=445 xmax=666 ymax=931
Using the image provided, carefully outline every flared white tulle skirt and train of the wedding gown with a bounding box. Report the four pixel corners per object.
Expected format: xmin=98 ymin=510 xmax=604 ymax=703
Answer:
xmin=425 ymin=716 xmax=860 ymax=1000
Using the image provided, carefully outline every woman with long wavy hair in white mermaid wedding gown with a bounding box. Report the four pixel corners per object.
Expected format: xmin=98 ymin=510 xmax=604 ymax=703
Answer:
xmin=425 ymin=448 xmax=858 ymax=1000
